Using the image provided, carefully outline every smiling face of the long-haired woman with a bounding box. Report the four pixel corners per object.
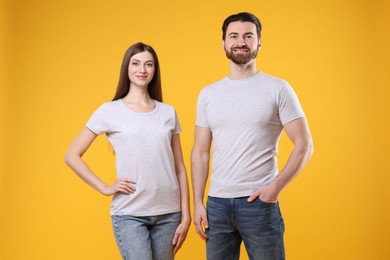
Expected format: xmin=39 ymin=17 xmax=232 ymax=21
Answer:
xmin=128 ymin=51 xmax=156 ymax=88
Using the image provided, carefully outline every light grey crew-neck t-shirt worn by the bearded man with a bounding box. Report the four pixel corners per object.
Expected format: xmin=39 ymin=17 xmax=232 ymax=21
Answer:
xmin=196 ymin=72 xmax=305 ymax=198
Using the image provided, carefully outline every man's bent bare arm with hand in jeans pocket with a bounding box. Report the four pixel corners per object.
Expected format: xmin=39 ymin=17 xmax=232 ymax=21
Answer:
xmin=248 ymin=118 xmax=314 ymax=203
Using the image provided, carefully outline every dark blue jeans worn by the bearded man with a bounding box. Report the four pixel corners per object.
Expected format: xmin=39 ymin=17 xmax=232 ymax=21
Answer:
xmin=206 ymin=196 xmax=285 ymax=260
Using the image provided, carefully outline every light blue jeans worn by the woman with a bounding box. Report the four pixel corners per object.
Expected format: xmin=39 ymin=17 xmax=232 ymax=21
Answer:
xmin=111 ymin=212 xmax=181 ymax=260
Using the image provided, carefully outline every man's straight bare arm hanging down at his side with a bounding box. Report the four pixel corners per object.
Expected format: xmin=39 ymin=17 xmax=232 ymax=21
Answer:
xmin=191 ymin=126 xmax=212 ymax=240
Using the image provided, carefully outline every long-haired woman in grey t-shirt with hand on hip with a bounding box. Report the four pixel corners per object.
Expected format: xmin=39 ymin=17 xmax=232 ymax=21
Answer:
xmin=65 ymin=43 xmax=191 ymax=260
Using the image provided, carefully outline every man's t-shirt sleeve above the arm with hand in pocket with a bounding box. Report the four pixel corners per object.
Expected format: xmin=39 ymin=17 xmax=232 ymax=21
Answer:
xmin=278 ymin=82 xmax=305 ymax=125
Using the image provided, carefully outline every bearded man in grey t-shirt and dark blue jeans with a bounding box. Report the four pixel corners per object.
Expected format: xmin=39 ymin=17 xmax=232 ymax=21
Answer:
xmin=191 ymin=13 xmax=313 ymax=260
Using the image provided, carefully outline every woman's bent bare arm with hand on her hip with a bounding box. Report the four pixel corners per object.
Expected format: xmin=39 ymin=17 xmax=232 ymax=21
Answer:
xmin=64 ymin=127 xmax=135 ymax=196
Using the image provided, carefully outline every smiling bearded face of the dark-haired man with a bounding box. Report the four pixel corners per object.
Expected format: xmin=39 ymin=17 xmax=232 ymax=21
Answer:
xmin=223 ymin=21 xmax=261 ymax=64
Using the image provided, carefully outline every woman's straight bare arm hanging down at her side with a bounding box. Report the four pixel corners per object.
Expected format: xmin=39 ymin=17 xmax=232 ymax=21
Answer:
xmin=171 ymin=134 xmax=191 ymax=254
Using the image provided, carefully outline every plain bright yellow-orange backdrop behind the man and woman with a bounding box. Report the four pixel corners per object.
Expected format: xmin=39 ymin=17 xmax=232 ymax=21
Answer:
xmin=0 ymin=0 xmax=390 ymax=260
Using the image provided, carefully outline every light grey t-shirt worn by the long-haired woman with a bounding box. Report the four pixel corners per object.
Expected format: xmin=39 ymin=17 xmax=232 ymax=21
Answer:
xmin=86 ymin=99 xmax=181 ymax=216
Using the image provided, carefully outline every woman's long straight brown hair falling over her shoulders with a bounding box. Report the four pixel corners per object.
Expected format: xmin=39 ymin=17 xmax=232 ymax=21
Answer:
xmin=112 ymin=42 xmax=162 ymax=102
